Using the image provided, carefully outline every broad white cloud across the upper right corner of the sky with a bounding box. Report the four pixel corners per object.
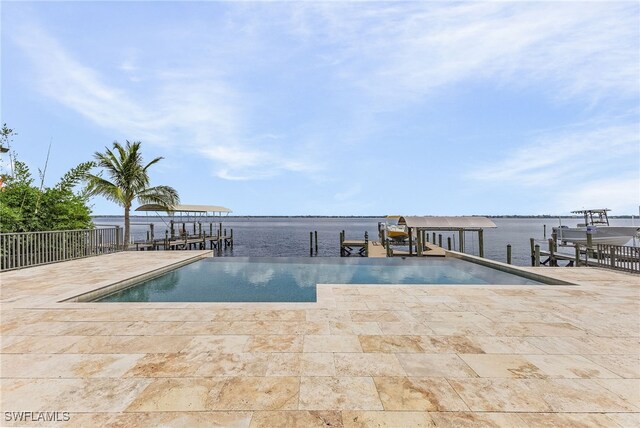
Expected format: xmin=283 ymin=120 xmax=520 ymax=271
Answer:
xmin=291 ymin=2 xmax=640 ymax=103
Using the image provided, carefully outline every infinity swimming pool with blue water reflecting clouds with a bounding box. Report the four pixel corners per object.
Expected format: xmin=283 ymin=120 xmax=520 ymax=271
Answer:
xmin=96 ymin=257 xmax=542 ymax=302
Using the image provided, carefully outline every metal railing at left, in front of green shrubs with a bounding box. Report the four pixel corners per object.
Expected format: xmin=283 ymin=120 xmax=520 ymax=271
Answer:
xmin=0 ymin=226 xmax=124 ymax=271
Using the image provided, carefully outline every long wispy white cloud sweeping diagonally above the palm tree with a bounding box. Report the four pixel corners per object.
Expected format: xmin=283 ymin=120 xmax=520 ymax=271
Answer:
xmin=14 ymin=26 xmax=318 ymax=180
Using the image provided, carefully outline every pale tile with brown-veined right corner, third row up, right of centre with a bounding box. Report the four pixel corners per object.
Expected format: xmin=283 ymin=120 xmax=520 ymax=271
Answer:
xmin=460 ymin=354 xmax=547 ymax=378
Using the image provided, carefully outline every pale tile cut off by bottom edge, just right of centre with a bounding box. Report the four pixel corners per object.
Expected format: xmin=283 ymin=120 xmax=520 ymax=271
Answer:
xmin=342 ymin=410 xmax=435 ymax=428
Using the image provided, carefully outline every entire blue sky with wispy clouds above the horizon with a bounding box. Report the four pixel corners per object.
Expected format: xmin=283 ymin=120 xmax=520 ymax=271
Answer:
xmin=1 ymin=1 xmax=640 ymax=215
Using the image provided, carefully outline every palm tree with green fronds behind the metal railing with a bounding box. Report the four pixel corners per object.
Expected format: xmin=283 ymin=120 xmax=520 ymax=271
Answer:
xmin=87 ymin=141 xmax=180 ymax=243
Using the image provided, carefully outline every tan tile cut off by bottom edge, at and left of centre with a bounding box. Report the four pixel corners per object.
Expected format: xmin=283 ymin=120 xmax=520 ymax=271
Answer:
xmin=251 ymin=410 xmax=343 ymax=428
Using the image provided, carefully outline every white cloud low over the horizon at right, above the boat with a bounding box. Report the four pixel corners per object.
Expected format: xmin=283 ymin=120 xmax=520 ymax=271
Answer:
xmin=466 ymin=124 xmax=640 ymax=214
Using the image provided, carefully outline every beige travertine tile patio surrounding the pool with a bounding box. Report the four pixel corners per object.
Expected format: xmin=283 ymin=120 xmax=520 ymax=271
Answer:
xmin=0 ymin=251 xmax=640 ymax=427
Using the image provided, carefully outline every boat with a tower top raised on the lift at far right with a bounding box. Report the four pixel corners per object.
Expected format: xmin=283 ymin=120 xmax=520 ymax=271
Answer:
xmin=553 ymin=208 xmax=640 ymax=246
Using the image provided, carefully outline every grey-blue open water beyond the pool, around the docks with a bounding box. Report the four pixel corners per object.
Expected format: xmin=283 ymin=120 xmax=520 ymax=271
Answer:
xmin=94 ymin=215 xmax=638 ymax=266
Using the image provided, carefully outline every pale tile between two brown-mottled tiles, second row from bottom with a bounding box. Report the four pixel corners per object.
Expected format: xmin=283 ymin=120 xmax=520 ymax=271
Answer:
xmin=299 ymin=377 xmax=383 ymax=410
